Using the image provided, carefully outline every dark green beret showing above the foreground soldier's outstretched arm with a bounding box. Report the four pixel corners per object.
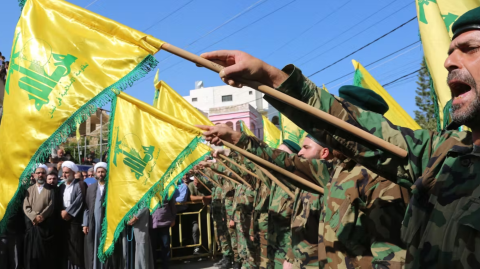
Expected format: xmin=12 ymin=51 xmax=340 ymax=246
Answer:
xmin=338 ymin=85 xmax=389 ymax=115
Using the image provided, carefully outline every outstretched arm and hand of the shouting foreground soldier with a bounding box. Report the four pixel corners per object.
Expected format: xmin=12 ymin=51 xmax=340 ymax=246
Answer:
xmin=202 ymin=51 xmax=451 ymax=186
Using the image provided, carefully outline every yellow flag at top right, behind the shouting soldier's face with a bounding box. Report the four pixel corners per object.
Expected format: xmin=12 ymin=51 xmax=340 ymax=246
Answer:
xmin=415 ymin=0 xmax=480 ymax=127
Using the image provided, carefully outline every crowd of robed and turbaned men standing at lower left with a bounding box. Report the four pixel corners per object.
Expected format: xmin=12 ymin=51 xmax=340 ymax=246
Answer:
xmin=0 ymin=149 xmax=216 ymax=269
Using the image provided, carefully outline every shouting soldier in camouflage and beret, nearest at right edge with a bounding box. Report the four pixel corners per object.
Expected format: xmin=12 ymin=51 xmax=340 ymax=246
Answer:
xmin=200 ymin=13 xmax=480 ymax=268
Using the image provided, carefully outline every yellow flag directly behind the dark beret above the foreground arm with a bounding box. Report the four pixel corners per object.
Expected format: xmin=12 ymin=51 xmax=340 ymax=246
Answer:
xmin=352 ymin=60 xmax=421 ymax=130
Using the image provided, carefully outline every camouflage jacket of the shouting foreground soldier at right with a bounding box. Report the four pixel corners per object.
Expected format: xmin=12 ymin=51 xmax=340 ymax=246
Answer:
xmin=267 ymin=65 xmax=480 ymax=268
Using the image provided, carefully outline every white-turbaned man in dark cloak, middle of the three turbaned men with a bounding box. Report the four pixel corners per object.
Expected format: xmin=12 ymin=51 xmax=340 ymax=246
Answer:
xmin=60 ymin=161 xmax=87 ymax=269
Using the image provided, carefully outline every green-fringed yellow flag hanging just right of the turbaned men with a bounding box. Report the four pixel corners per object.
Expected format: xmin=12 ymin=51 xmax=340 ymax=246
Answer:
xmin=99 ymin=93 xmax=209 ymax=260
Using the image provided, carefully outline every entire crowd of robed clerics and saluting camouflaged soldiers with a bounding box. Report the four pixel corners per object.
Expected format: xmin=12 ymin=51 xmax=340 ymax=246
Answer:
xmin=0 ymin=3 xmax=480 ymax=269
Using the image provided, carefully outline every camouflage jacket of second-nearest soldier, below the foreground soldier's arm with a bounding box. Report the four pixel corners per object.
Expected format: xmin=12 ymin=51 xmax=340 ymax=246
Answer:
xmin=239 ymin=131 xmax=409 ymax=268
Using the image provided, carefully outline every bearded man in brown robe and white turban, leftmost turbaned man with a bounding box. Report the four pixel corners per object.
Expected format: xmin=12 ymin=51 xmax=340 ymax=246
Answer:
xmin=23 ymin=164 xmax=55 ymax=269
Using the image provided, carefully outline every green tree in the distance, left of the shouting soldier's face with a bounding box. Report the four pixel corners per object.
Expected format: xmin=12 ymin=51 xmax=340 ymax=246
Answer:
xmin=414 ymin=60 xmax=437 ymax=131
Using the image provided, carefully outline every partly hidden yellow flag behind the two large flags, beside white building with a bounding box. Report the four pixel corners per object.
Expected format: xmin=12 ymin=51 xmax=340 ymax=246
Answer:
xmin=153 ymin=71 xmax=213 ymax=125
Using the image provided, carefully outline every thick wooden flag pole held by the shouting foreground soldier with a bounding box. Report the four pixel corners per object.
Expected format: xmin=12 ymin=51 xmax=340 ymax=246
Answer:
xmin=162 ymin=43 xmax=408 ymax=158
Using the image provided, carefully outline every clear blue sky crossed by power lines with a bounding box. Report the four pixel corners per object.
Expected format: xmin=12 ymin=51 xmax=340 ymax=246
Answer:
xmin=0 ymin=0 xmax=423 ymax=117
